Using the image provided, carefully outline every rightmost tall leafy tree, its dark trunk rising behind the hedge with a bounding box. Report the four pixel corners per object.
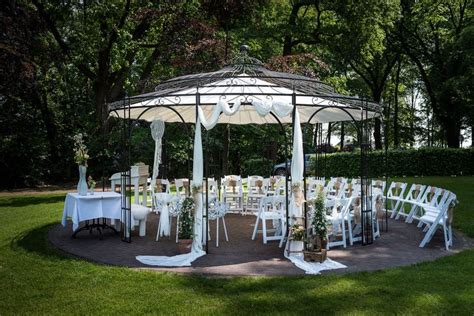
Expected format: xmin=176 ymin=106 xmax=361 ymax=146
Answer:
xmin=399 ymin=0 xmax=473 ymax=147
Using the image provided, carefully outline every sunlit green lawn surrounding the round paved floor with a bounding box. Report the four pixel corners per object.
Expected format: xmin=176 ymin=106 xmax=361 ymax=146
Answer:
xmin=0 ymin=177 xmax=474 ymax=315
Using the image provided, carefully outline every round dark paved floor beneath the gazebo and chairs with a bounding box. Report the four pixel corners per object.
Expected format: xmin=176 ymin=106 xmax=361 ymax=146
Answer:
xmin=48 ymin=214 xmax=474 ymax=275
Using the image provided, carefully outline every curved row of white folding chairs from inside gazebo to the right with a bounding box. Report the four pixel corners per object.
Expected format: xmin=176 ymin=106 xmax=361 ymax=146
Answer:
xmin=147 ymin=175 xmax=456 ymax=249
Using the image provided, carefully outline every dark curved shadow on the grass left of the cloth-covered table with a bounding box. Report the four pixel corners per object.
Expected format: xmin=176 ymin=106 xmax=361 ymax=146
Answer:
xmin=10 ymin=223 xmax=74 ymax=261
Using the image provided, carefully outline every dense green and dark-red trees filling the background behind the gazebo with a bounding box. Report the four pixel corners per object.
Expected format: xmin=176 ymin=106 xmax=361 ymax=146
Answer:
xmin=0 ymin=0 xmax=474 ymax=187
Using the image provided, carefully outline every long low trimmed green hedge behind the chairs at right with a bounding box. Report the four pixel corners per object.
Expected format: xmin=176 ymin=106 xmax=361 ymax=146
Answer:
xmin=312 ymin=148 xmax=474 ymax=177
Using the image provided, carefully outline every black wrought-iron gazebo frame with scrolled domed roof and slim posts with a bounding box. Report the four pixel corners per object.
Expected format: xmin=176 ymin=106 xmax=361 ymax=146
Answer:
xmin=109 ymin=45 xmax=388 ymax=250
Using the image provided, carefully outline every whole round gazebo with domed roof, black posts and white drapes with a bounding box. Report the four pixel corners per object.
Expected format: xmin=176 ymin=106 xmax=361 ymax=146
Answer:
xmin=109 ymin=45 xmax=382 ymax=270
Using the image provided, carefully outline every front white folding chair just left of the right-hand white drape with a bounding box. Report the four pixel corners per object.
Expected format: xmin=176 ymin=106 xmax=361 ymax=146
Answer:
xmin=252 ymin=195 xmax=285 ymax=244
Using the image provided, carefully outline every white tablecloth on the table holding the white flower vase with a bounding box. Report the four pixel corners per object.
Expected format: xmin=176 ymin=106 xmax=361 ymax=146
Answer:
xmin=62 ymin=192 xmax=122 ymax=230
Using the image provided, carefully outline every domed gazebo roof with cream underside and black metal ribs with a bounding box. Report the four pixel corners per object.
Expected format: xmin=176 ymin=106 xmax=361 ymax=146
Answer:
xmin=109 ymin=46 xmax=381 ymax=124
